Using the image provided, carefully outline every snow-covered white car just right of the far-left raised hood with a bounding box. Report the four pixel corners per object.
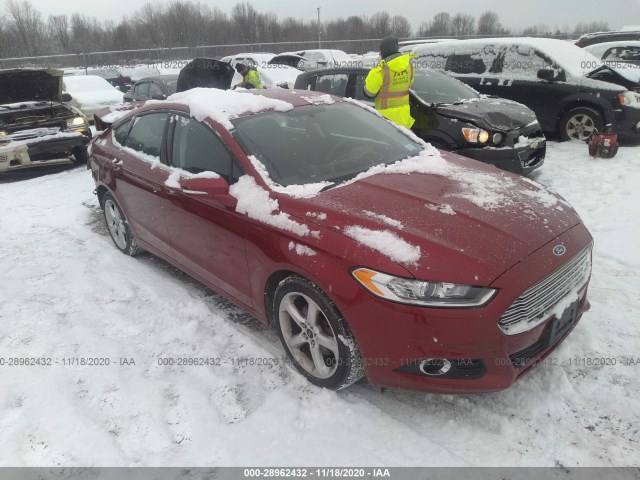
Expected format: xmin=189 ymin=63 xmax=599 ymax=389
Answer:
xmin=63 ymin=75 xmax=123 ymax=122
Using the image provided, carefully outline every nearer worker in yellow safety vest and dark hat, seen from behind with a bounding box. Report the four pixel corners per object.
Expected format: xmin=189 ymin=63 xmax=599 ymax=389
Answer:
xmin=364 ymin=37 xmax=415 ymax=128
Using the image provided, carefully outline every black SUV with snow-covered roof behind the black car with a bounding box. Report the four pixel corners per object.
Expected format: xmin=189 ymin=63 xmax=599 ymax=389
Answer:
xmin=413 ymin=38 xmax=640 ymax=140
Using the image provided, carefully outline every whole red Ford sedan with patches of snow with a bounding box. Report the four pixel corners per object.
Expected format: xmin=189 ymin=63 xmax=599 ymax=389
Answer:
xmin=89 ymin=88 xmax=592 ymax=393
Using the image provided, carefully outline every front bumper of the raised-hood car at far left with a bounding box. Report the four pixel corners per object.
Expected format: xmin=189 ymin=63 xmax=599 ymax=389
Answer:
xmin=0 ymin=129 xmax=91 ymax=173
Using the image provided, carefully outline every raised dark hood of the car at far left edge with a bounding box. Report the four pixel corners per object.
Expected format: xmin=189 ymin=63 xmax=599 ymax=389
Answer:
xmin=0 ymin=68 xmax=63 ymax=105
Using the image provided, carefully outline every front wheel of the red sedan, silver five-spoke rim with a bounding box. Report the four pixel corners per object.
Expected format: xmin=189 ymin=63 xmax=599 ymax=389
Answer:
xmin=271 ymin=275 xmax=364 ymax=390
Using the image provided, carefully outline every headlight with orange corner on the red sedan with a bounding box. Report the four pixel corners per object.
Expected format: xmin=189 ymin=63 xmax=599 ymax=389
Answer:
xmin=351 ymin=268 xmax=497 ymax=308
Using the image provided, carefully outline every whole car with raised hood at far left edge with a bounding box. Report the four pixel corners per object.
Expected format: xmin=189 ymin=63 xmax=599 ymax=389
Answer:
xmin=0 ymin=68 xmax=91 ymax=173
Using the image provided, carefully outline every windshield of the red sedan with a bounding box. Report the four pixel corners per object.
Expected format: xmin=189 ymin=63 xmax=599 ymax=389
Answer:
xmin=233 ymin=103 xmax=422 ymax=186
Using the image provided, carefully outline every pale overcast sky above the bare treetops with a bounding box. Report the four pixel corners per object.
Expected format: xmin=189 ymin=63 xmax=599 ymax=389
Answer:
xmin=23 ymin=0 xmax=640 ymax=30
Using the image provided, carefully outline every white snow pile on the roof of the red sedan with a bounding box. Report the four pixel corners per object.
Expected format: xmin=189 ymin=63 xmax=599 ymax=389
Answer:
xmin=165 ymin=88 xmax=293 ymax=130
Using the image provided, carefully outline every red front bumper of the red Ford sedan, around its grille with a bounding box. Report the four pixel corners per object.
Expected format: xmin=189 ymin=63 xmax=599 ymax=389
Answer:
xmin=341 ymin=225 xmax=592 ymax=393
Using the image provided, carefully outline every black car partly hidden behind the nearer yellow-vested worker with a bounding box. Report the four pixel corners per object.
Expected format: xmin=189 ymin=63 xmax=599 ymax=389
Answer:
xmin=295 ymin=68 xmax=546 ymax=175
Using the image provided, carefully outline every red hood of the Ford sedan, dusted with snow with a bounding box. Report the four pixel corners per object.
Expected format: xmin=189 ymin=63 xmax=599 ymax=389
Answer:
xmin=278 ymin=153 xmax=581 ymax=285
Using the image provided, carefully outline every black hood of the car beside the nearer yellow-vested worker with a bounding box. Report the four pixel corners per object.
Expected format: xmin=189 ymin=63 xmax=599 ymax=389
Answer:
xmin=436 ymin=98 xmax=537 ymax=132
